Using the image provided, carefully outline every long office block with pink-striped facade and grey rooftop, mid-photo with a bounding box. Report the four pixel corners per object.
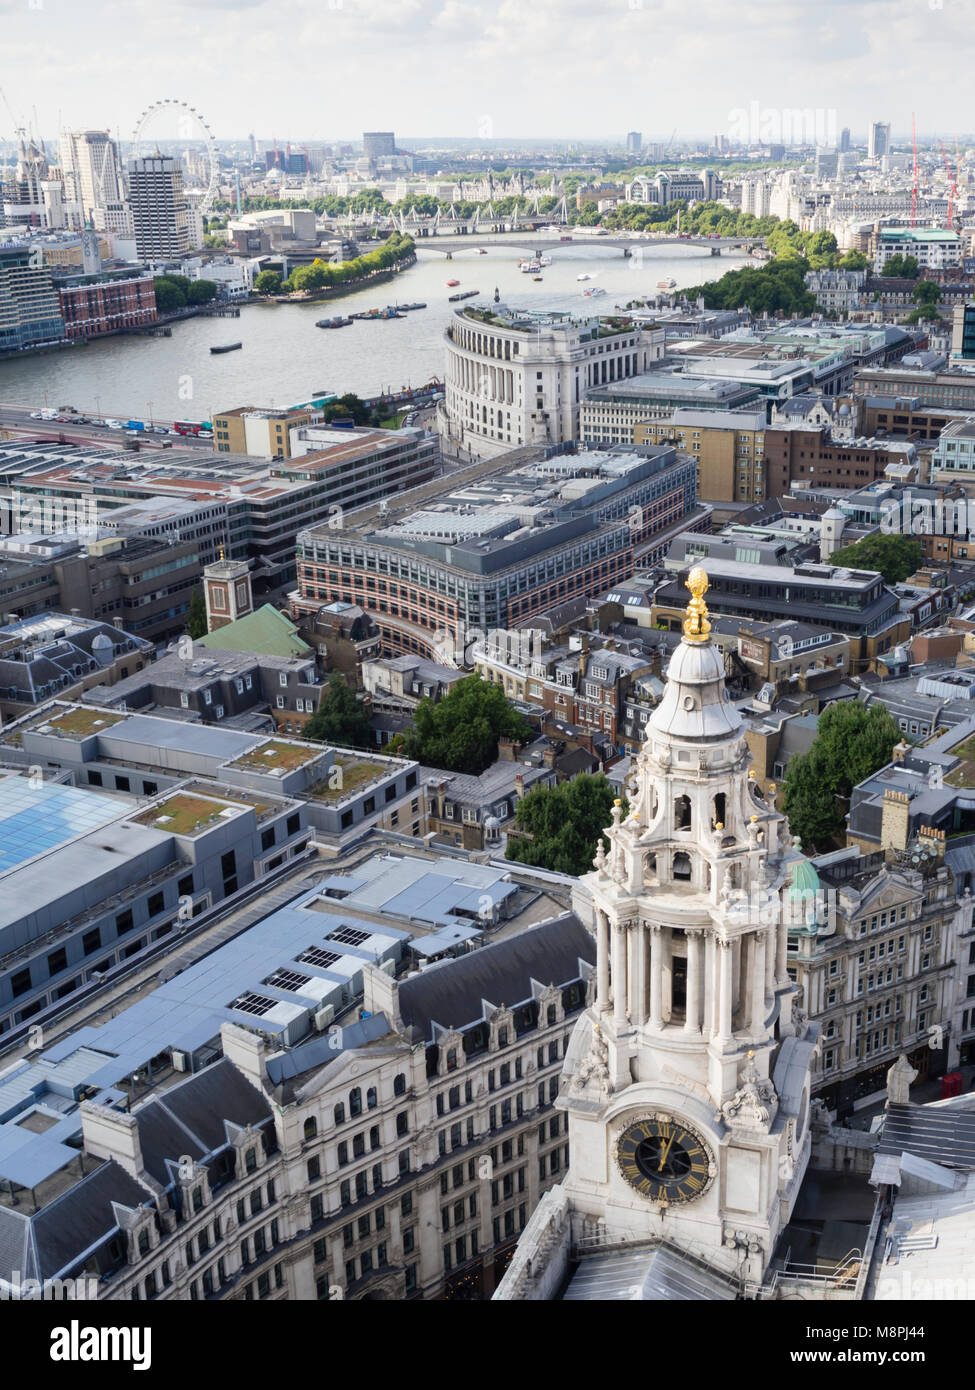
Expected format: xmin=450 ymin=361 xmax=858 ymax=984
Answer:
xmin=292 ymin=445 xmax=697 ymax=664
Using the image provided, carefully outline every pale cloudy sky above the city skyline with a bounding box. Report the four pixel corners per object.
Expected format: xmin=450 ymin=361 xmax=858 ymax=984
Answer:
xmin=0 ymin=0 xmax=975 ymax=142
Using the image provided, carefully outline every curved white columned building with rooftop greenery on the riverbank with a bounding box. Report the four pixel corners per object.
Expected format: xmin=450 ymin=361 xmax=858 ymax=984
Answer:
xmin=440 ymin=304 xmax=663 ymax=459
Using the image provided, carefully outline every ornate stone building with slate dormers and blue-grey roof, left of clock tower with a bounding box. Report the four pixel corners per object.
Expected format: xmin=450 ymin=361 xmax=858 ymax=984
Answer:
xmin=0 ymin=834 xmax=593 ymax=1302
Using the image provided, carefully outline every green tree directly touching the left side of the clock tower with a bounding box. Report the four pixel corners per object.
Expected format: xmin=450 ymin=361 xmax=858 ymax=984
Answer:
xmin=505 ymin=773 xmax=626 ymax=874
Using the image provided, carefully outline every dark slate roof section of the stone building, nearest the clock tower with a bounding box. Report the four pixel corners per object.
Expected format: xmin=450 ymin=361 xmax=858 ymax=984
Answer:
xmin=399 ymin=912 xmax=595 ymax=1041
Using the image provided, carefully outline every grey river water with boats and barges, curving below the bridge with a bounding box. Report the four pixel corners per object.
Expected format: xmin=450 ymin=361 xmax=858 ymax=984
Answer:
xmin=0 ymin=238 xmax=748 ymax=420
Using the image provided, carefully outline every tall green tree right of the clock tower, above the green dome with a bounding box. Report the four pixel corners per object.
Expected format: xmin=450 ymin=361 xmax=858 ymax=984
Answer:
xmin=783 ymin=701 xmax=901 ymax=851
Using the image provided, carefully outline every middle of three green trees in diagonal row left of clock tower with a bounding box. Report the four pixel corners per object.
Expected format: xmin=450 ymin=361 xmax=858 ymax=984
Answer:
xmin=403 ymin=676 xmax=531 ymax=777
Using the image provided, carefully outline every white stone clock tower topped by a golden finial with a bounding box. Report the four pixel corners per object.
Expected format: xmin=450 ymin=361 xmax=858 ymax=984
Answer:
xmin=559 ymin=569 xmax=816 ymax=1282
